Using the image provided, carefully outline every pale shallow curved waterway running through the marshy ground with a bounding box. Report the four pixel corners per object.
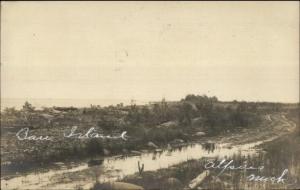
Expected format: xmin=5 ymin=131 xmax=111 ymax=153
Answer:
xmin=1 ymin=141 xmax=272 ymax=189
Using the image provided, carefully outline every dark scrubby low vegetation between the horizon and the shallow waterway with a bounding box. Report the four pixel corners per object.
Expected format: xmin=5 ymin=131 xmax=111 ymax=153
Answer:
xmin=1 ymin=95 xmax=294 ymax=176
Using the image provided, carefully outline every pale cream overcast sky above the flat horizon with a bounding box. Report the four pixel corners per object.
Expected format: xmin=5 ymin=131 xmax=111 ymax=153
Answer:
xmin=1 ymin=2 xmax=299 ymax=102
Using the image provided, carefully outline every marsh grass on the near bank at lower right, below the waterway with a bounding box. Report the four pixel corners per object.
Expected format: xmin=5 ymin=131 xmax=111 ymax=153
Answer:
xmin=113 ymin=133 xmax=300 ymax=190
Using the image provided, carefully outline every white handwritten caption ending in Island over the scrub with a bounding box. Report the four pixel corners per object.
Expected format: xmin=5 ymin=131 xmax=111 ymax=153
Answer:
xmin=16 ymin=126 xmax=128 ymax=141
